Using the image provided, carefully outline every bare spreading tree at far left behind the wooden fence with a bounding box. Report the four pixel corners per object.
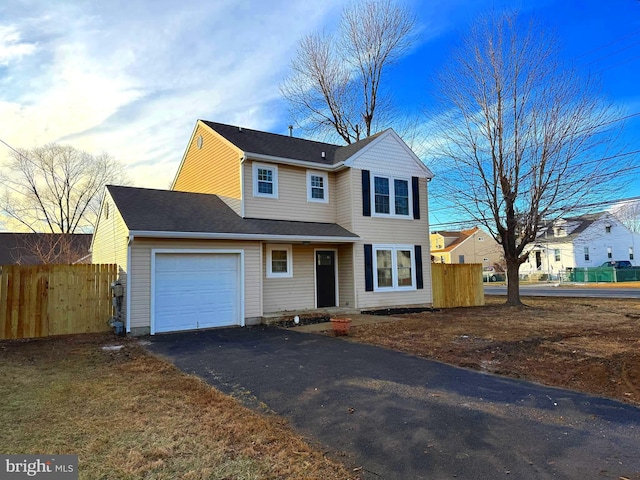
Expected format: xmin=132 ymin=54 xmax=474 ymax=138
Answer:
xmin=2 ymin=144 xmax=126 ymax=234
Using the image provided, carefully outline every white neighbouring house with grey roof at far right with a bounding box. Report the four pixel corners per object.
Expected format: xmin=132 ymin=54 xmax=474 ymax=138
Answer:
xmin=520 ymin=212 xmax=640 ymax=276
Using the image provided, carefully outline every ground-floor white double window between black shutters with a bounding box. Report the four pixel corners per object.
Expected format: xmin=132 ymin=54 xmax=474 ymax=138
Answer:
xmin=373 ymin=245 xmax=416 ymax=291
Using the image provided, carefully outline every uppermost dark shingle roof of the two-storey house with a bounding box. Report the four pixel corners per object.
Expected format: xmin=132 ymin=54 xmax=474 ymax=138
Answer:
xmin=201 ymin=120 xmax=383 ymax=166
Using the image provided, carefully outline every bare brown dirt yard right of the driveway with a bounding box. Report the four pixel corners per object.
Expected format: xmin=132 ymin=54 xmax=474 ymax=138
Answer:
xmin=351 ymin=297 xmax=640 ymax=404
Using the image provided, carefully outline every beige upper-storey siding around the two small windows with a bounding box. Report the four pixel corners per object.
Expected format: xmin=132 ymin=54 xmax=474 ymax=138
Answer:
xmin=244 ymin=161 xmax=336 ymax=223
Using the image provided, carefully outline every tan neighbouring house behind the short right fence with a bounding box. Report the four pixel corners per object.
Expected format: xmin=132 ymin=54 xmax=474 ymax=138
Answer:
xmin=429 ymin=227 xmax=503 ymax=266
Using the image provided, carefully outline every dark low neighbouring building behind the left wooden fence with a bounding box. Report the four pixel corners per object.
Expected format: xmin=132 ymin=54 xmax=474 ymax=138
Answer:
xmin=0 ymin=232 xmax=92 ymax=265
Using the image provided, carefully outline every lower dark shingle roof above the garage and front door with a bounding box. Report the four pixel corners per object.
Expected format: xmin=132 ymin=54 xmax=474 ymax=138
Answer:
xmin=107 ymin=185 xmax=359 ymax=242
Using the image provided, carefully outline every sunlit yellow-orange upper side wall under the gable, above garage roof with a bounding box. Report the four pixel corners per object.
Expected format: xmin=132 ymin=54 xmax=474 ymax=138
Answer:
xmin=173 ymin=122 xmax=242 ymax=214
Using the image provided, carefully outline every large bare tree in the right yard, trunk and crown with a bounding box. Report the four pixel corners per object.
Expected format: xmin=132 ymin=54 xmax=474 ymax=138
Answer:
xmin=432 ymin=13 xmax=620 ymax=305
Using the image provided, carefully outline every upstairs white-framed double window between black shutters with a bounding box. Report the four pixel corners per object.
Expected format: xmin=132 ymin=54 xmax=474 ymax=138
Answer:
xmin=371 ymin=175 xmax=412 ymax=218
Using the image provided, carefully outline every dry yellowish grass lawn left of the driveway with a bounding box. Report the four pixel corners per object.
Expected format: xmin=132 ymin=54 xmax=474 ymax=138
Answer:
xmin=0 ymin=335 xmax=354 ymax=480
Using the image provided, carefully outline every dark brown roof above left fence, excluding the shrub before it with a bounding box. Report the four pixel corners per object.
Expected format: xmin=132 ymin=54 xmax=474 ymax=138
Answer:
xmin=0 ymin=232 xmax=91 ymax=265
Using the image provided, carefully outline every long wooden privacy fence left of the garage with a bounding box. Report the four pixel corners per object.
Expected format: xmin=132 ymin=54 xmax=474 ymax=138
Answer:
xmin=0 ymin=264 xmax=118 ymax=339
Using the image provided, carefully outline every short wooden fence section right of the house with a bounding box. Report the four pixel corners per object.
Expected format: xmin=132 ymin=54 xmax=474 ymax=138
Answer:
xmin=431 ymin=263 xmax=484 ymax=308
